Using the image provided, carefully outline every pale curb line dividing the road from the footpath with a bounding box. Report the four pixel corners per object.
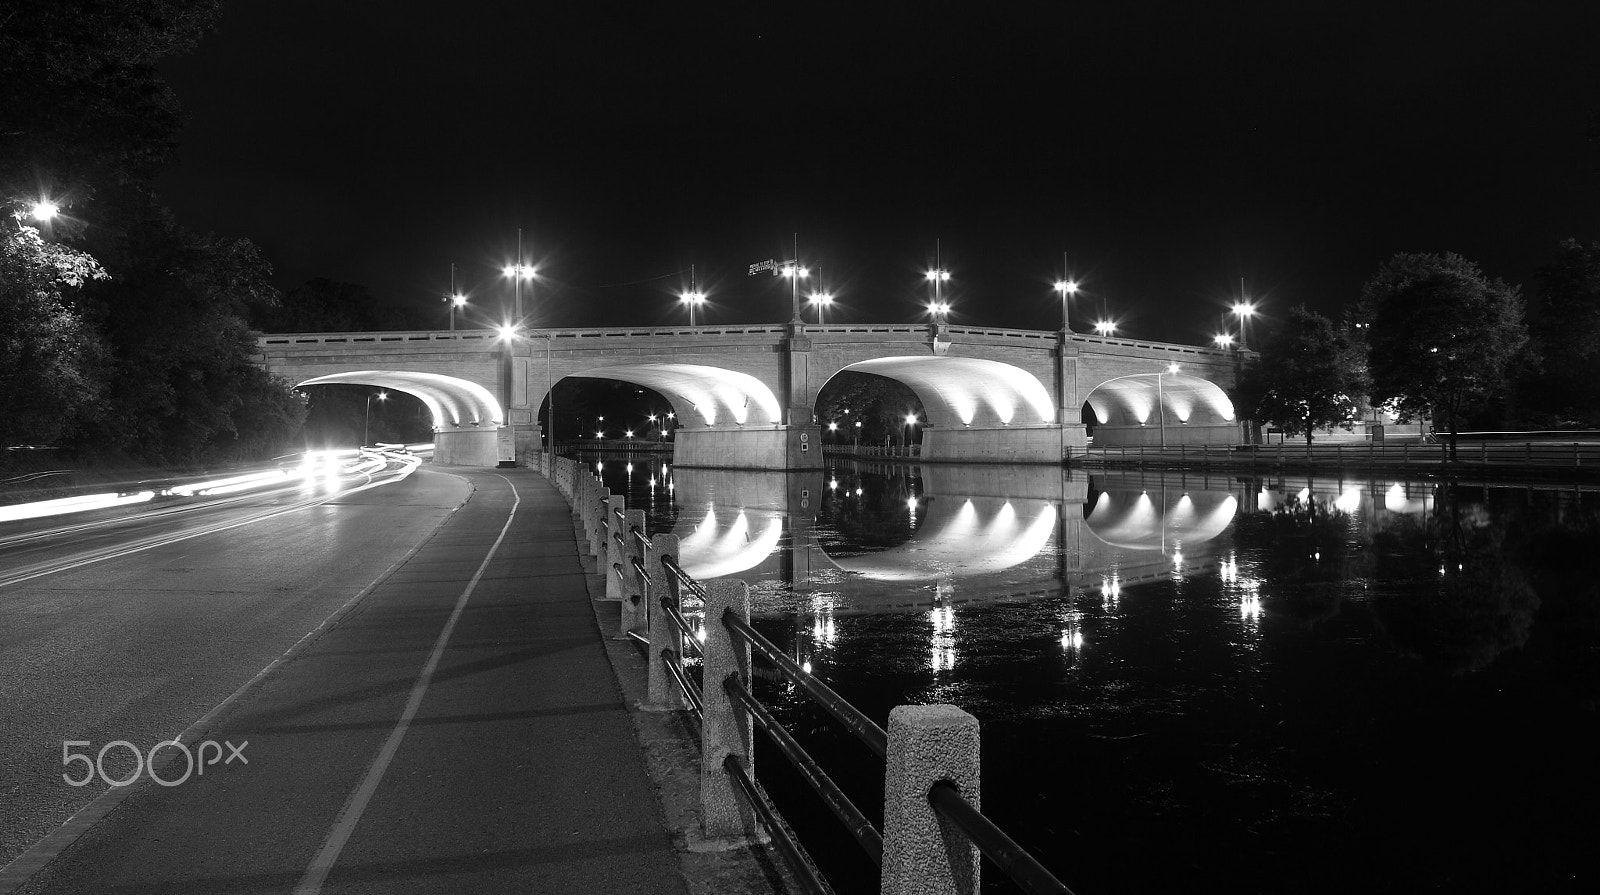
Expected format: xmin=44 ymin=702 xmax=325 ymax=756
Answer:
xmin=0 ymin=476 xmax=467 ymax=895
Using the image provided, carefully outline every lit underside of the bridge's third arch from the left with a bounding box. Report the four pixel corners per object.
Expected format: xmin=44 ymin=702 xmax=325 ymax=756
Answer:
xmin=845 ymin=357 xmax=1056 ymax=426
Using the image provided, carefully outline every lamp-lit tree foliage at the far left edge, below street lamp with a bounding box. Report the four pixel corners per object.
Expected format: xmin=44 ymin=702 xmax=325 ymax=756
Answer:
xmin=0 ymin=227 xmax=106 ymax=445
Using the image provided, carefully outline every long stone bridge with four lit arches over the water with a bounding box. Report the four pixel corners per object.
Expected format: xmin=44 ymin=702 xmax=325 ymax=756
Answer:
xmin=258 ymin=323 xmax=1242 ymax=469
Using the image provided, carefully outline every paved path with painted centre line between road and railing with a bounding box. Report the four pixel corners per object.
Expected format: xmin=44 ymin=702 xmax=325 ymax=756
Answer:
xmin=9 ymin=471 xmax=771 ymax=893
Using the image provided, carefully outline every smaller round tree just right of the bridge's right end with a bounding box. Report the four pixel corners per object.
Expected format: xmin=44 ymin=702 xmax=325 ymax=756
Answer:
xmin=1235 ymin=306 xmax=1371 ymax=445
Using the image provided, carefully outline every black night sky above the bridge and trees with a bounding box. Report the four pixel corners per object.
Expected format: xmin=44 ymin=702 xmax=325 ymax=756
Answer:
xmin=152 ymin=0 xmax=1600 ymax=343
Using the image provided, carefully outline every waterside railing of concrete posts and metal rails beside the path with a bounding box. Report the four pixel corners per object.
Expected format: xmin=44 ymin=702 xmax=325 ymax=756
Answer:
xmin=537 ymin=458 xmax=1070 ymax=895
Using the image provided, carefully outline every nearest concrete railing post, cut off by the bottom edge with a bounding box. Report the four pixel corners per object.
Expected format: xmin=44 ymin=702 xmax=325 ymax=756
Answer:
xmin=878 ymin=704 xmax=982 ymax=895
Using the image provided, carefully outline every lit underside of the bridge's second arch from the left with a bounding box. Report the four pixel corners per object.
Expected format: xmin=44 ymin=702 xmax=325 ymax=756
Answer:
xmin=573 ymin=363 xmax=782 ymax=427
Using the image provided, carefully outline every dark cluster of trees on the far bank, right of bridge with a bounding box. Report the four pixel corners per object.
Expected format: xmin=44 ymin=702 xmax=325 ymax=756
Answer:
xmin=1234 ymin=240 xmax=1600 ymax=448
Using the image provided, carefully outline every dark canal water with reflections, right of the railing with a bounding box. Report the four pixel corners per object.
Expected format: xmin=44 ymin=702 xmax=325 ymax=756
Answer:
xmin=588 ymin=458 xmax=1600 ymax=895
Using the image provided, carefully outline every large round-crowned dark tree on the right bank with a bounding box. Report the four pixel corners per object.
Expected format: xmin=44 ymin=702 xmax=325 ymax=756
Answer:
xmin=1360 ymin=253 xmax=1530 ymax=452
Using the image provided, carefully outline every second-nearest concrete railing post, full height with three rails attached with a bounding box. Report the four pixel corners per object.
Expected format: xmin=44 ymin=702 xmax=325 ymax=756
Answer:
xmin=701 ymin=578 xmax=765 ymax=841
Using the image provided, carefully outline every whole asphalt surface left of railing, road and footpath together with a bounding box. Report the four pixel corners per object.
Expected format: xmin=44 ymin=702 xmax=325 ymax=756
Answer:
xmin=0 ymin=469 xmax=683 ymax=893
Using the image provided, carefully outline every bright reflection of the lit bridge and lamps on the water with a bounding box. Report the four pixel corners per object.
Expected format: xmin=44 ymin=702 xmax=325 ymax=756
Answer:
xmin=600 ymin=458 xmax=1432 ymax=631
